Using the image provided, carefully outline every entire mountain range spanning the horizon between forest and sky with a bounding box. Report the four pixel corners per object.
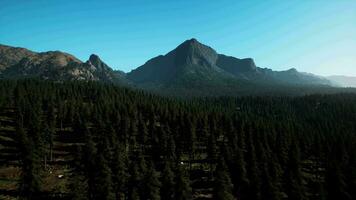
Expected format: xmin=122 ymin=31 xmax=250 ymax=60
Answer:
xmin=0 ymin=39 xmax=355 ymax=96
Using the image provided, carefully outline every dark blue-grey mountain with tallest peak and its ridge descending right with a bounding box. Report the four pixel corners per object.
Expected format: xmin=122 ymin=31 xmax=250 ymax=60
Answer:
xmin=127 ymin=38 xmax=331 ymax=95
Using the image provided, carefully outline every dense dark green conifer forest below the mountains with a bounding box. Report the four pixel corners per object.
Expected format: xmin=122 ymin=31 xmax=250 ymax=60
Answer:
xmin=0 ymin=79 xmax=356 ymax=200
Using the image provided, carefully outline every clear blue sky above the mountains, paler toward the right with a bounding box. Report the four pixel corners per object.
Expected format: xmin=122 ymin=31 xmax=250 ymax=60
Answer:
xmin=0 ymin=0 xmax=356 ymax=76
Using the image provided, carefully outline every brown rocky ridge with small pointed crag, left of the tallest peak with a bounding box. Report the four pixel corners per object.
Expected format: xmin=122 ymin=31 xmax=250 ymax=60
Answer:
xmin=0 ymin=45 xmax=125 ymax=82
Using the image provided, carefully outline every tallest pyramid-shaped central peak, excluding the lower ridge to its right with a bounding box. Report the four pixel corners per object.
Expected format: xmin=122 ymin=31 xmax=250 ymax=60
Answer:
xmin=127 ymin=39 xmax=227 ymax=85
